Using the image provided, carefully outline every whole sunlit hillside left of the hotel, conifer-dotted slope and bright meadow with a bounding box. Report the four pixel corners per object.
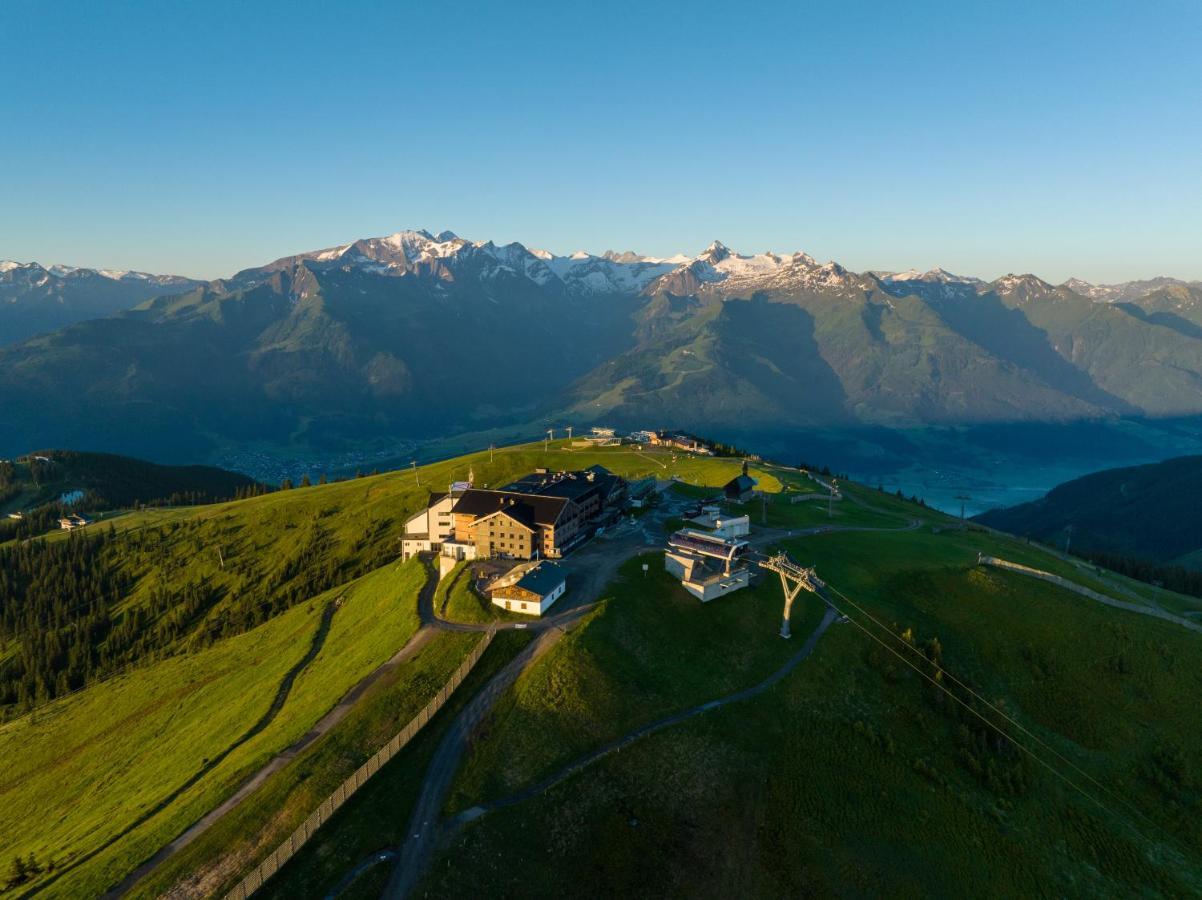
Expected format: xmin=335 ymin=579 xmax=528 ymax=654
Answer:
xmin=0 ymin=443 xmax=774 ymax=890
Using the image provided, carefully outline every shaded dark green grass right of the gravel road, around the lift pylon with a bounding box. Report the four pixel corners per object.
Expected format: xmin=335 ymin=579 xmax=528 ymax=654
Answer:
xmin=421 ymin=516 xmax=1202 ymax=896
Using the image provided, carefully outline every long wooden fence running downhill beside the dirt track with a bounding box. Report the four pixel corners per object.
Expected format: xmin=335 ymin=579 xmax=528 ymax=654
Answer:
xmin=226 ymin=628 xmax=495 ymax=900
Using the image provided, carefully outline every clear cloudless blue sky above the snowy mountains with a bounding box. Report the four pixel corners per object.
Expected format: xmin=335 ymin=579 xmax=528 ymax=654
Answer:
xmin=0 ymin=0 xmax=1202 ymax=281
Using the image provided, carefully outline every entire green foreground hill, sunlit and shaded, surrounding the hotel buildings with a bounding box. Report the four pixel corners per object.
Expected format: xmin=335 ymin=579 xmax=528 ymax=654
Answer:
xmin=0 ymin=441 xmax=1202 ymax=896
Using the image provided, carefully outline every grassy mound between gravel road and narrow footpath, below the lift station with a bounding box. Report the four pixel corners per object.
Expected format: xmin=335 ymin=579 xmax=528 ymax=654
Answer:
xmin=448 ymin=554 xmax=820 ymax=811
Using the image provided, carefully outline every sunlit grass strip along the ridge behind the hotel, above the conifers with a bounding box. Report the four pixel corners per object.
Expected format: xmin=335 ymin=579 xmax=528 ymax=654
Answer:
xmin=42 ymin=442 xmax=781 ymax=624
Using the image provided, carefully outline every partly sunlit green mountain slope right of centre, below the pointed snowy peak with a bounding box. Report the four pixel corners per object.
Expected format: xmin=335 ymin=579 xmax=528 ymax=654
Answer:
xmin=570 ymin=282 xmax=1105 ymax=427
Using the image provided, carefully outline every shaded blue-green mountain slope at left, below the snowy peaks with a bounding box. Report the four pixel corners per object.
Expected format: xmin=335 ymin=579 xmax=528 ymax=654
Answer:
xmin=0 ymin=258 xmax=633 ymax=459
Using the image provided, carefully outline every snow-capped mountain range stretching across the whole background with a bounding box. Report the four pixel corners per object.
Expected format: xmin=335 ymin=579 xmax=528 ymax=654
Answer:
xmin=0 ymin=231 xmax=1202 ymax=460
